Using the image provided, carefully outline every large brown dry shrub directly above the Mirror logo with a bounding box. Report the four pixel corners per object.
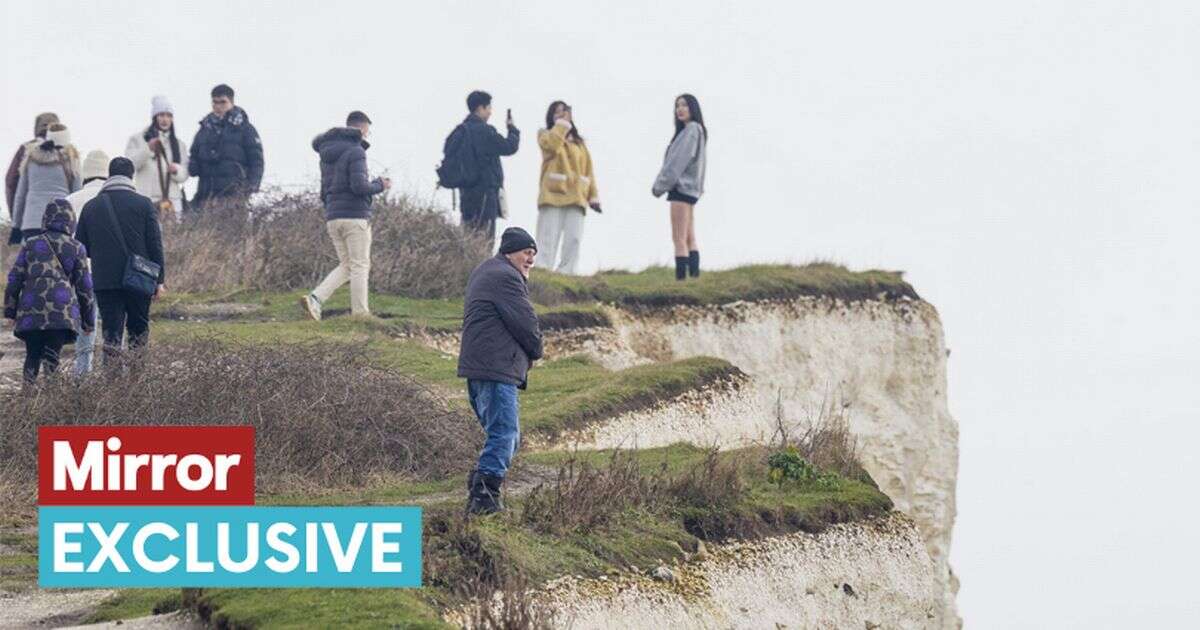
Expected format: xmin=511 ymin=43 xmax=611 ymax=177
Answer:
xmin=0 ymin=340 xmax=481 ymax=502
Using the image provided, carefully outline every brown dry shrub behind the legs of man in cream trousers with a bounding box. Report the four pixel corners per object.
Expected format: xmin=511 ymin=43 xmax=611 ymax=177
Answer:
xmin=163 ymin=193 xmax=488 ymax=298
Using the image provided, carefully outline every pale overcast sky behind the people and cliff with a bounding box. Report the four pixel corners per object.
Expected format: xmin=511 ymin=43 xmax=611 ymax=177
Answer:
xmin=0 ymin=0 xmax=1200 ymax=628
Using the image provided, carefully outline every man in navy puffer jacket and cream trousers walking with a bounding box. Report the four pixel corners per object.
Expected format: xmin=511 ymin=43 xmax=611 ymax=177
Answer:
xmin=300 ymin=112 xmax=391 ymax=322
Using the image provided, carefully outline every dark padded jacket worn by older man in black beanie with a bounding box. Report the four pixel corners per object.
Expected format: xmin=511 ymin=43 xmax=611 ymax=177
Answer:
xmin=458 ymin=254 xmax=541 ymax=389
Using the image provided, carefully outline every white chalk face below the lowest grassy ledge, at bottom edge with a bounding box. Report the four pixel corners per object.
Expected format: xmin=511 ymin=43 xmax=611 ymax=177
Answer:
xmin=536 ymin=514 xmax=948 ymax=629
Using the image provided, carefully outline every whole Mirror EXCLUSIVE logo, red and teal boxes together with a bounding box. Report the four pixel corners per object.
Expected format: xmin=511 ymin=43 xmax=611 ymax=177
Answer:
xmin=37 ymin=426 xmax=421 ymax=588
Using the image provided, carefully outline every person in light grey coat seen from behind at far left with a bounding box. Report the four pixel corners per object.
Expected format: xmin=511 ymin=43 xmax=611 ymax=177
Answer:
xmin=12 ymin=122 xmax=82 ymax=240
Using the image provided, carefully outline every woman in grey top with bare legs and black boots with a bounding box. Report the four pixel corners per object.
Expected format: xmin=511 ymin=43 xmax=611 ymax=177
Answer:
xmin=652 ymin=94 xmax=708 ymax=280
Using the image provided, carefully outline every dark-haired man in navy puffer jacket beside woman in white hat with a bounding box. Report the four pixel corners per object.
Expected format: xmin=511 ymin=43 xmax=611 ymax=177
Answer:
xmin=187 ymin=84 xmax=263 ymax=209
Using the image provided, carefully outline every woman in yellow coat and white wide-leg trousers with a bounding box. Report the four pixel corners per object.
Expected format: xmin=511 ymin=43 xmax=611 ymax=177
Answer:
xmin=538 ymin=101 xmax=600 ymax=274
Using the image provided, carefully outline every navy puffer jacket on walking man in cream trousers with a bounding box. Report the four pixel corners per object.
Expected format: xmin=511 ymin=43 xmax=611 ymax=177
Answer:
xmin=312 ymin=127 xmax=383 ymax=221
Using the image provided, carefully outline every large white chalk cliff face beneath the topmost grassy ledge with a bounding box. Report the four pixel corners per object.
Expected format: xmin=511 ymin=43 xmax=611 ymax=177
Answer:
xmin=557 ymin=298 xmax=959 ymax=628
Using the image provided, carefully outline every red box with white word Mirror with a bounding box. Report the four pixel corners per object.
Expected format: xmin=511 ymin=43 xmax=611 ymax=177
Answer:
xmin=37 ymin=426 xmax=254 ymax=505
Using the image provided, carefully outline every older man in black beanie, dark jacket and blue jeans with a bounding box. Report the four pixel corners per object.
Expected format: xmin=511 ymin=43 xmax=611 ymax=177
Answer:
xmin=458 ymin=228 xmax=541 ymax=514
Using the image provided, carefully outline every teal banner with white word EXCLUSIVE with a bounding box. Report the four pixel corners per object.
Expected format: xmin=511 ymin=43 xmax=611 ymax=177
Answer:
xmin=37 ymin=505 xmax=421 ymax=588
